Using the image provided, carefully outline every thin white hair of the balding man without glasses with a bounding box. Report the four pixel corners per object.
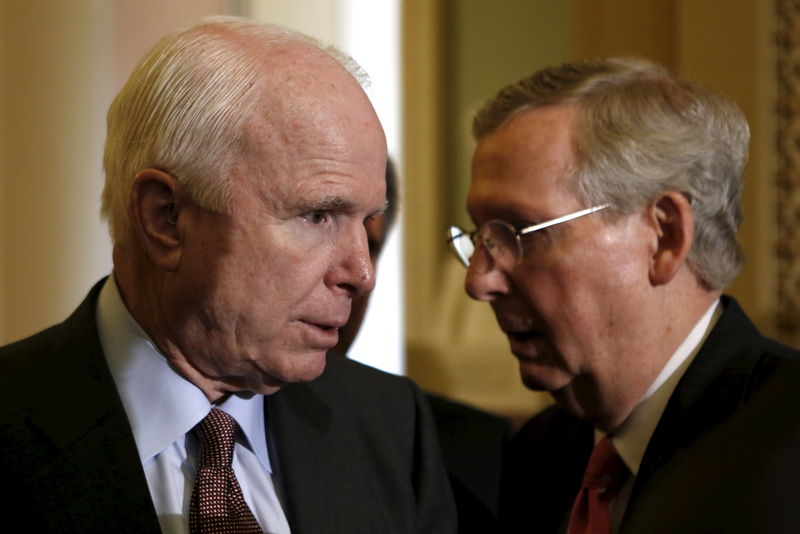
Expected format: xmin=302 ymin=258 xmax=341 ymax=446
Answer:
xmin=101 ymin=17 xmax=369 ymax=243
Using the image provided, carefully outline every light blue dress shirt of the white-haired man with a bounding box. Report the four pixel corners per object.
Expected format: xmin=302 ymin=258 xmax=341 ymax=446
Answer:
xmin=97 ymin=275 xmax=289 ymax=534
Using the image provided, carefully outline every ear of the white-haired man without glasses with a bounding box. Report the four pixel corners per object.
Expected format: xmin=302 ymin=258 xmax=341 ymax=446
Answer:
xmin=128 ymin=169 xmax=185 ymax=271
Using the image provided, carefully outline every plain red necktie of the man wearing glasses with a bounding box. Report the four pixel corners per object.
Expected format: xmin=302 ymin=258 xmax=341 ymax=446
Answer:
xmin=567 ymin=437 xmax=628 ymax=534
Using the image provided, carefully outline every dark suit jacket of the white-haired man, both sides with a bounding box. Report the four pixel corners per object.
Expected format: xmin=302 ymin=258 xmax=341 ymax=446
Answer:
xmin=0 ymin=284 xmax=455 ymax=534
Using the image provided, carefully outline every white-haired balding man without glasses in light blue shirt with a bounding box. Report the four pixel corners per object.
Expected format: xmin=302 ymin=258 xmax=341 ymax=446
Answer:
xmin=0 ymin=19 xmax=455 ymax=534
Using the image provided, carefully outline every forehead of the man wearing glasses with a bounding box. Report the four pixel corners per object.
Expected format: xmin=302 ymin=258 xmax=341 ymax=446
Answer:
xmin=467 ymin=106 xmax=580 ymax=222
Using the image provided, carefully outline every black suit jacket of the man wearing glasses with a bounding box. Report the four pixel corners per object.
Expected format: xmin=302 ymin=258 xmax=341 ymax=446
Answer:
xmin=500 ymin=297 xmax=797 ymax=533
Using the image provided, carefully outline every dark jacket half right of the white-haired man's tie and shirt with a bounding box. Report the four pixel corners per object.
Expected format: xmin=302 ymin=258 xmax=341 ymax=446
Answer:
xmin=267 ymin=355 xmax=456 ymax=534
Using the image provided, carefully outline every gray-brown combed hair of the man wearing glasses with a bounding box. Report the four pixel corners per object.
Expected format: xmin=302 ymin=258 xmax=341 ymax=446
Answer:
xmin=473 ymin=58 xmax=750 ymax=289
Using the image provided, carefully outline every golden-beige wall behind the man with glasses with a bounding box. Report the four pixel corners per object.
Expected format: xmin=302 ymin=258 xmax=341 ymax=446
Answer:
xmin=405 ymin=0 xmax=775 ymax=422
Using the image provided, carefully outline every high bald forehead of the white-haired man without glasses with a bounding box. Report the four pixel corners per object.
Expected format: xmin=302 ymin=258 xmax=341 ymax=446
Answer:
xmin=238 ymin=47 xmax=386 ymax=209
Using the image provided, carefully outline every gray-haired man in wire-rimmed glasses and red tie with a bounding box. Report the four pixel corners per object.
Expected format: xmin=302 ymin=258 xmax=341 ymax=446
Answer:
xmin=451 ymin=58 xmax=796 ymax=534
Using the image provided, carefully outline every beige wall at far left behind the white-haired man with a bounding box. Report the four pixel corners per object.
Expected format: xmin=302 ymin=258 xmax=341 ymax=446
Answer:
xmin=0 ymin=0 xmax=230 ymax=343
